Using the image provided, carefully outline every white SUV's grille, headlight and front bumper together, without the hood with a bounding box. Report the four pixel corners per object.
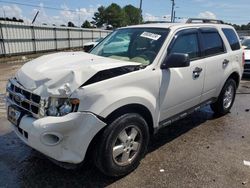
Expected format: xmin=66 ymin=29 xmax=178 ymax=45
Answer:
xmin=6 ymin=79 xmax=106 ymax=164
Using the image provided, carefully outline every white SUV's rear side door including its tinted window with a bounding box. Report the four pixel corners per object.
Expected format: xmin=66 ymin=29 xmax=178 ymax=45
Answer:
xmin=199 ymin=28 xmax=230 ymax=102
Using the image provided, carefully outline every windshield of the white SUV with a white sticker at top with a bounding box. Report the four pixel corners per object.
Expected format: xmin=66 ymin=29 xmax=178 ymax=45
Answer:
xmin=90 ymin=28 xmax=169 ymax=65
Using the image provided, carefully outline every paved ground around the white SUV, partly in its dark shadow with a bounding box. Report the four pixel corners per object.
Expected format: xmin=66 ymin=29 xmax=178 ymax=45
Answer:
xmin=0 ymin=64 xmax=250 ymax=188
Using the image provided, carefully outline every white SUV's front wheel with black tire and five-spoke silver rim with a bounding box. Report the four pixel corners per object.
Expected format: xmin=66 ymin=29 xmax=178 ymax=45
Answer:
xmin=94 ymin=113 xmax=149 ymax=176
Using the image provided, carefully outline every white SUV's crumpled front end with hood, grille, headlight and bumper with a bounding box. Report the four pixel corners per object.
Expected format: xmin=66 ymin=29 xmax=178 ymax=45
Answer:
xmin=6 ymin=53 xmax=143 ymax=164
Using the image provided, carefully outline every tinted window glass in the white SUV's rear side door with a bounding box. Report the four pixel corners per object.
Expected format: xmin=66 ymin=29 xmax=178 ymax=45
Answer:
xmin=202 ymin=32 xmax=225 ymax=56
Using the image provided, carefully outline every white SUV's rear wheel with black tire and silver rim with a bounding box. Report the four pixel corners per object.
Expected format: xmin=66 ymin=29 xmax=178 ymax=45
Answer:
xmin=210 ymin=78 xmax=237 ymax=116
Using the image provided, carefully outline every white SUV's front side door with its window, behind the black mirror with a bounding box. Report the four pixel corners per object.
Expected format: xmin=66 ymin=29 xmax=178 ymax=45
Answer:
xmin=159 ymin=29 xmax=206 ymax=122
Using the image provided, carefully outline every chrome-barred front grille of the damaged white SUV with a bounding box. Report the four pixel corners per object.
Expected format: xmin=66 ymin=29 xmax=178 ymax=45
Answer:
xmin=7 ymin=79 xmax=41 ymax=116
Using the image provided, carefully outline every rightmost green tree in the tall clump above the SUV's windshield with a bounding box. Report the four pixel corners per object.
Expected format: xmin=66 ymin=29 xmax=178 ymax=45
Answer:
xmin=123 ymin=5 xmax=142 ymax=25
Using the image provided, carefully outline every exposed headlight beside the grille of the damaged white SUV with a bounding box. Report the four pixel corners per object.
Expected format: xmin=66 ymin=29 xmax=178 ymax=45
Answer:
xmin=47 ymin=97 xmax=80 ymax=116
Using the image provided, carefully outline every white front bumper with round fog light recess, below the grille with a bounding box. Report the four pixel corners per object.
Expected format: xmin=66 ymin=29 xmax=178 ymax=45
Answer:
xmin=9 ymin=112 xmax=106 ymax=164
